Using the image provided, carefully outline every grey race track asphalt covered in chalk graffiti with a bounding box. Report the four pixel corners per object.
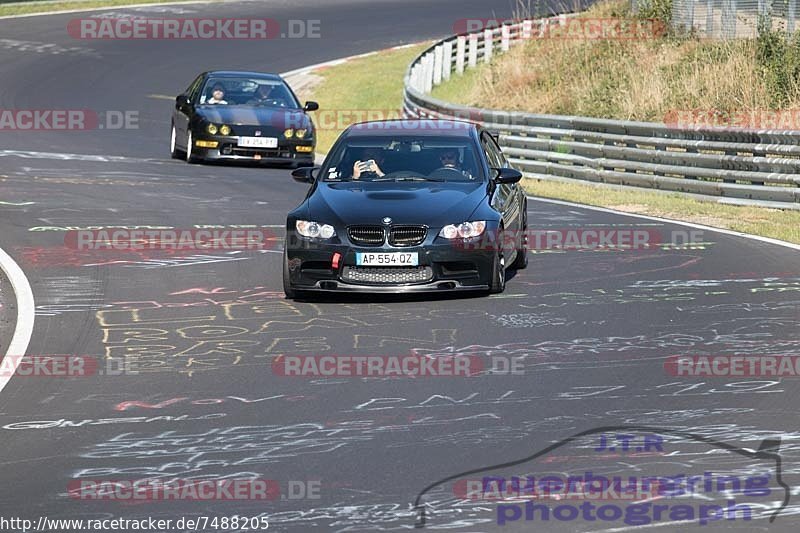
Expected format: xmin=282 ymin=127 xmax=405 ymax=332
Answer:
xmin=0 ymin=0 xmax=800 ymax=532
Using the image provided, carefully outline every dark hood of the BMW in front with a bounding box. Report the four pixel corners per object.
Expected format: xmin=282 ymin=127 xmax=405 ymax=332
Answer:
xmin=308 ymin=181 xmax=486 ymax=227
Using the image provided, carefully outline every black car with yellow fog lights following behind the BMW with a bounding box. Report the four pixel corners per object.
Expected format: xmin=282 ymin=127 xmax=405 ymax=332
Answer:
xmin=170 ymin=71 xmax=319 ymax=167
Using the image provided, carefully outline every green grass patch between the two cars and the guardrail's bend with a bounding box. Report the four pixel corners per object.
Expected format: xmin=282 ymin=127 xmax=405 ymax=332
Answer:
xmin=304 ymin=44 xmax=429 ymax=152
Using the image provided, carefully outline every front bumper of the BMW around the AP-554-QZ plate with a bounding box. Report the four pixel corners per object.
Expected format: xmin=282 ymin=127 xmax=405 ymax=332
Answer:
xmin=286 ymin=238 xmax=494 ymax=293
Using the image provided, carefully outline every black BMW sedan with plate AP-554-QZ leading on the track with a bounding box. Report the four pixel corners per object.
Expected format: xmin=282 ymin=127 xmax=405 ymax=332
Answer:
xmin=283 ymin=120 xmax=527 ymax=298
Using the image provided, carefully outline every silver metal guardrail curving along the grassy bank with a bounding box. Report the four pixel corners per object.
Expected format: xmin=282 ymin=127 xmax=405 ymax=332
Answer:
xmin=403 ymin=15 xmax=800 ymax=208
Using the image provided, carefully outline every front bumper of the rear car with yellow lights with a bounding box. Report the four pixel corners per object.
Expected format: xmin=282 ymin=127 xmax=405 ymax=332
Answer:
xmin=192 ymin=134 xmax=315 ymax=165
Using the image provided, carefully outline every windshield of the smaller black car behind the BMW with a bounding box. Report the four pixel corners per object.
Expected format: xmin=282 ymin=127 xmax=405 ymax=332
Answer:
xmin=198 ymin=77 xmax=300 ymax=108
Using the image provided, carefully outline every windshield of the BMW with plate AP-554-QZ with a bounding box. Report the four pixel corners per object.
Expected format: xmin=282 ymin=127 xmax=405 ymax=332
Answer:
xmin=320 ymin=135 xmax=483 ymax=182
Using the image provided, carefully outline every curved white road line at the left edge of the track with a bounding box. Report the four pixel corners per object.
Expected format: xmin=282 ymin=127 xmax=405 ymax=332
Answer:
xmin=0 ymin=243 xmax=36 ymax=392
